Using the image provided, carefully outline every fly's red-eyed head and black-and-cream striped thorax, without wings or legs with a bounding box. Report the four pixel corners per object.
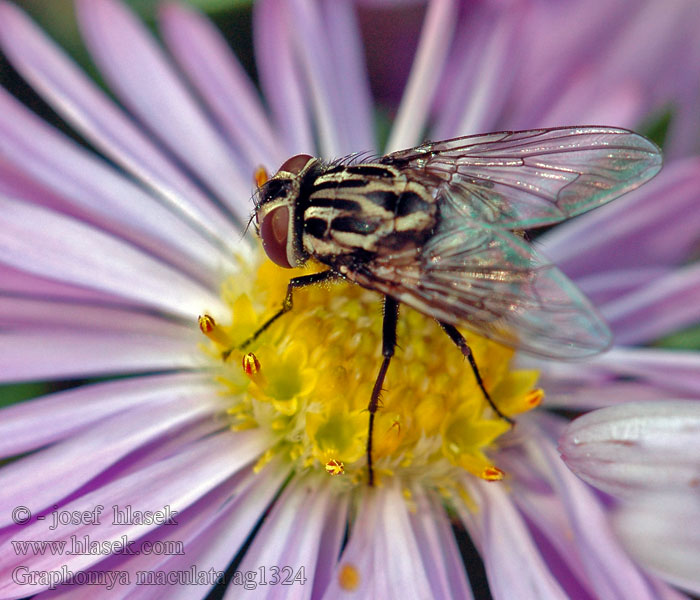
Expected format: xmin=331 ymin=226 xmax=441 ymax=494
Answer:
xmin=256 ymin=155 xmax=438 ymax=274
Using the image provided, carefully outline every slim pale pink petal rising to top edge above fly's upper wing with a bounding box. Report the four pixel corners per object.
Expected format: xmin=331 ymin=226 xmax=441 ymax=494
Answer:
xmin=386 ymin=0 xmax=457 ymax=152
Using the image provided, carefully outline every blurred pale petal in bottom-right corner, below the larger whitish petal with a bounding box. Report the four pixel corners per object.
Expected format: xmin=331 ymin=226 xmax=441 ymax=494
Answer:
xmin=615 ymin=494 xmax=700 ymax=594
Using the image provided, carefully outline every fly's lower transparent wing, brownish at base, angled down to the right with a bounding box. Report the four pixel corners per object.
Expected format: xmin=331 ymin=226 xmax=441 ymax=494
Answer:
xmin=351 ymin=213 xmax=612 ymax=359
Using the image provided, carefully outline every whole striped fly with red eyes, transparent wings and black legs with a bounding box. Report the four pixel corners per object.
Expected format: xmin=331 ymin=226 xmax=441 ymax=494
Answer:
xmin=234 ymin=127 xmax=662 ymax=485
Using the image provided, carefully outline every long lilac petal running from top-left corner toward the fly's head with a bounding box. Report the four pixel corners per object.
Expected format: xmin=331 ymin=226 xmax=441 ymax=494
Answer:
xmin=0 ymin=2 xmax=238 ymax=241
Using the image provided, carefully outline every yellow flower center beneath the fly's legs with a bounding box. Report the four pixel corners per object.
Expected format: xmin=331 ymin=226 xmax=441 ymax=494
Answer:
xmin=200 ymin=251 xmax=542 ymax=488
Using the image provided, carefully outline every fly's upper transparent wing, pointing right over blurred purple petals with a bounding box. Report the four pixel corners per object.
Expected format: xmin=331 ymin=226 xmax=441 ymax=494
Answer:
xmin=381 ymin=127 xmax=662 ymax=229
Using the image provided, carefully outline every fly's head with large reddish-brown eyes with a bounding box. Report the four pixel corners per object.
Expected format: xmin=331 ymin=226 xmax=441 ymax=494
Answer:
xmin=255 ymin=154 xmax=320 ymax=269
